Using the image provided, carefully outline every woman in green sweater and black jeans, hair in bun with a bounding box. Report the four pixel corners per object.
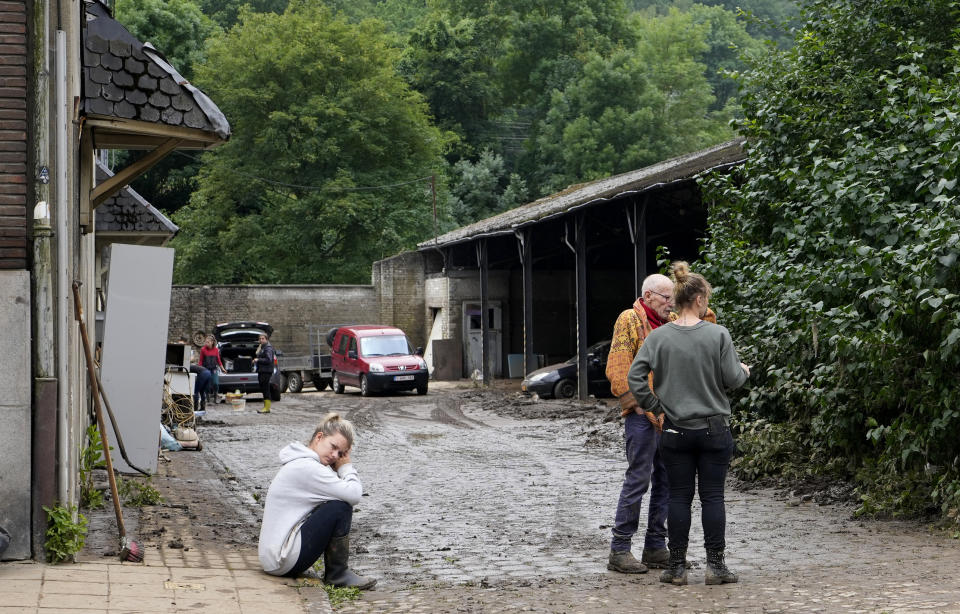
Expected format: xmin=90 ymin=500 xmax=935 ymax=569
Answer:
xmin=627 ymin=262 xmax=750 ymax=585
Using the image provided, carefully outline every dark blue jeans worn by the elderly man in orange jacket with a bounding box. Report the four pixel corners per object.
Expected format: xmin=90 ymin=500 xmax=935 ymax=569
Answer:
xmin=610 ymin=412 xmax=670 ymax=552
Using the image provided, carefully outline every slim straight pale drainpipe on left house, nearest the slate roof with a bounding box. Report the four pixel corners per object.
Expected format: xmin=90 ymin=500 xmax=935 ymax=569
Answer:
xmin=54 ymin=30 xmax=72 ymax=505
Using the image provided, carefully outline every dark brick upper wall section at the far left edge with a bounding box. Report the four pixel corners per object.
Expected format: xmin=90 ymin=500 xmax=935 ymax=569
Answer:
xmin=0 ymin=1 xmax=27 ymax=269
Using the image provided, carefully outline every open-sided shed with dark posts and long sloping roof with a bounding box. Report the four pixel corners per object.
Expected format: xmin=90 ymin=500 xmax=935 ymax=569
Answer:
xmin=408 ymin=139 xmax=745 ymax=398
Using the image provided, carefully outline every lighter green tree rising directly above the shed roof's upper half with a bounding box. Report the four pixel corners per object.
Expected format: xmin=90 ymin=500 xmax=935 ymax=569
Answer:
xmin=532 ymin=11 xmax=730 ymax=193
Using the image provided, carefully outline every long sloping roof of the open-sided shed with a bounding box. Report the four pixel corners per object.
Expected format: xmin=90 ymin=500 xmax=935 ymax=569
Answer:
xmin=418 ymin=138 xmax=746 ymax=250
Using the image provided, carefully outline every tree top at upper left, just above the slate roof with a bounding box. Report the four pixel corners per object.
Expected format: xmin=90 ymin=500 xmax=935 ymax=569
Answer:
xmin=113 ymin=0 xmax=217 ymax=79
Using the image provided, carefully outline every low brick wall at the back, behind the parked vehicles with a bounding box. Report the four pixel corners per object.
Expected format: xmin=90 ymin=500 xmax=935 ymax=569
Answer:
xmin=168 ymin=285 xmax=380 ymax=355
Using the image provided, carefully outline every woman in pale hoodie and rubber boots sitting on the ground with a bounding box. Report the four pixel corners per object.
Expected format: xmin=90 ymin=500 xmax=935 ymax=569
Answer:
xmin=259 ymin=412 xmax=377 ymax=590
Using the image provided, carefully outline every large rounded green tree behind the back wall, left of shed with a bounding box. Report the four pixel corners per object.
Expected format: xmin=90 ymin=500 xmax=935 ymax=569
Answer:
xmin=174 ymin=2 xmax=449 ymax=283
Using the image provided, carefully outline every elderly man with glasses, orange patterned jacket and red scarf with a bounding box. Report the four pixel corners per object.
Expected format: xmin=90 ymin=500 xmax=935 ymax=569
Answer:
xmin=606 ymin=274 xmax=716 ymax=573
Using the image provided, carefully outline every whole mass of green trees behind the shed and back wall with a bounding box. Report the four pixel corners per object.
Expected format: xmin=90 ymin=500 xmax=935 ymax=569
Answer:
xmin=115 ymin=0 xmax=792 ymax=283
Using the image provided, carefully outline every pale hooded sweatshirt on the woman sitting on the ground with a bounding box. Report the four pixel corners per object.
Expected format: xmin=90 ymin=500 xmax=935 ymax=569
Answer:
xmin=259 ymin=442 xmax=363 ymax=576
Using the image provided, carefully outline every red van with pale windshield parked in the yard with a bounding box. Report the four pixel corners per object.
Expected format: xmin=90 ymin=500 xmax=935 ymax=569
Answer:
xmin=328 ymin=325 xmax=430 ymax=397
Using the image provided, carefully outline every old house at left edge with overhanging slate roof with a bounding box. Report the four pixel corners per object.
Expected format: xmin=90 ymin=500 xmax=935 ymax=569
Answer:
xmin=0 ymin=0 xmax=229 ymax=559
